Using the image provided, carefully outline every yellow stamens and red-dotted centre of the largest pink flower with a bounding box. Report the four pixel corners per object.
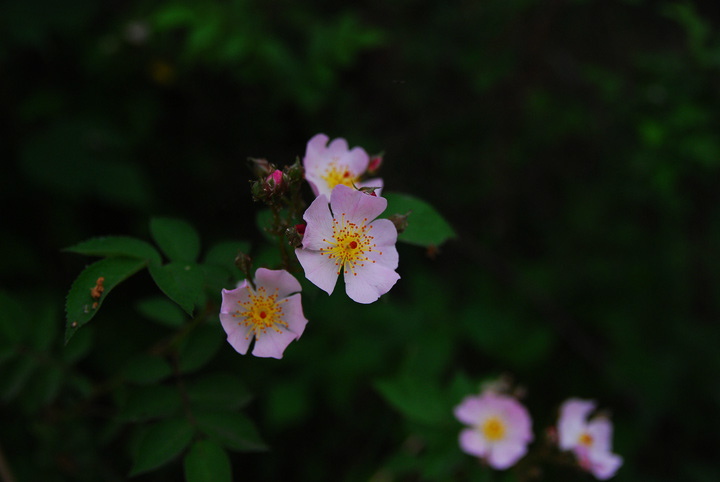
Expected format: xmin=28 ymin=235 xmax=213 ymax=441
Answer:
xmin=320 ymin=213 xmax=382 ymax=276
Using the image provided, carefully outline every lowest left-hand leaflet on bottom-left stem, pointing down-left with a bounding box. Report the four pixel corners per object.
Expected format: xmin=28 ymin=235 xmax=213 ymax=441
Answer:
xmin=130 ymin=418 xmax=194 ymax=476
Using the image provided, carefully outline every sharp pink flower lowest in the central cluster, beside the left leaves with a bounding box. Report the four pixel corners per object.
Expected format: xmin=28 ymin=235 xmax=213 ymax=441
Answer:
xmin=220 ymin=268 xmax=307 ymax=358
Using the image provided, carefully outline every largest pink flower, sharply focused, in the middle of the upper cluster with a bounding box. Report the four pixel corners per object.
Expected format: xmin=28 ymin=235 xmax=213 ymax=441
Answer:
xmin=295 ymin=185 xmax=400 ymax=303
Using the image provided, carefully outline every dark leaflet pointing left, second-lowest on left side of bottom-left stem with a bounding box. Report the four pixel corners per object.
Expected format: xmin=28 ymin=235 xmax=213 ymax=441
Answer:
xmin=119 ymin=385 xmax=182 ymax=422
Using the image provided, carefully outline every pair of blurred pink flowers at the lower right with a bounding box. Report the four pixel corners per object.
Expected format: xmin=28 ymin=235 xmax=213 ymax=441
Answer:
xmin=455 ymin=387 xmax=623 ymax=480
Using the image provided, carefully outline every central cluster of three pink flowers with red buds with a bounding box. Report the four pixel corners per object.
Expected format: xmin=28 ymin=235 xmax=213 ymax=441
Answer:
xmin=220 ymin=134 xmax=400 ymax=358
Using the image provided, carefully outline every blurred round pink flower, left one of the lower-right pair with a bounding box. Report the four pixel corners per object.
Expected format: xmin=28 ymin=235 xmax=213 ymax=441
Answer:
xmin=455 ymin=390 xmax=533 ymax=469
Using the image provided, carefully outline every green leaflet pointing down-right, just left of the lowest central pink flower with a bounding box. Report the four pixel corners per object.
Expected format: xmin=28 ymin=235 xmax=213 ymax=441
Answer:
xmin=149 ymin=261 xmax=205 ymax=316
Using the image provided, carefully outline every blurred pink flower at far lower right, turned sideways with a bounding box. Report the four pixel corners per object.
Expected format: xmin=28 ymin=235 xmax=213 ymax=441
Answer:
xmin=558 ymin=398 xmax=623 ymax=480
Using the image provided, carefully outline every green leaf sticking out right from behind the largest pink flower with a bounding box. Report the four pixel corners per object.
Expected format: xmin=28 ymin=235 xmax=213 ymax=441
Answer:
xmin=383 ymin=193 xmax=455 ymax=247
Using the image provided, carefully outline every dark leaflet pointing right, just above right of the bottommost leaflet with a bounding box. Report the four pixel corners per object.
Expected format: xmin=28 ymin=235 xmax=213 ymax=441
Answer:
xmin=195 ymin=411 xmax=268 ymax=452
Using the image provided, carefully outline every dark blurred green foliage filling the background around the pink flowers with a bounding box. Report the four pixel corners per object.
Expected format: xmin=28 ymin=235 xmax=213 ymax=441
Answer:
xmin=0 ymin=0 xmax=720 ymax=482
